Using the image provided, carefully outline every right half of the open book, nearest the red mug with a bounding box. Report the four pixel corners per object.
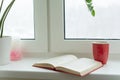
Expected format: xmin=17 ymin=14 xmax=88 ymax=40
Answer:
xmin=56 ymin=58 xmax=102 ymax=76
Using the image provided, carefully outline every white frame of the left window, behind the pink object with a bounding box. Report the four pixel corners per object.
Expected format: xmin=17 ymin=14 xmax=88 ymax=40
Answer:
xmin=21 ymin=0 xmax=48 ymax=56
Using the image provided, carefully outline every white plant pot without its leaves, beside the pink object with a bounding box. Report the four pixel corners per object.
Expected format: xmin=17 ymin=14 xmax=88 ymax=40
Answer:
xmin=0 ymin=36 xmax=12 ymax=66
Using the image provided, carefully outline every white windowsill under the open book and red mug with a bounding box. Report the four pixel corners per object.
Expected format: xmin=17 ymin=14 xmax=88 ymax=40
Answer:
xmin=0 ymin=55 xmax=120 ymax=80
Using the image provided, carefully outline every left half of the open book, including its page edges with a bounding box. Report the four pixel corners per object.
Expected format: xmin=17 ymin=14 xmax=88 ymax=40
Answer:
xmin=33 ymin=55 xmax=77 ymax=69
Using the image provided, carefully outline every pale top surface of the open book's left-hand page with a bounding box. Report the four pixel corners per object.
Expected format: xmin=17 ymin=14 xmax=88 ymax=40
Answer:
xmin=32 ymin=55 xmax=77 ymax=67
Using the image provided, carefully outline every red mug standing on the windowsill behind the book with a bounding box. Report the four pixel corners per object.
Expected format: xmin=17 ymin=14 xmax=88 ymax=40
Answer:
xmin=93 ymin=42 xmax=109 ymax=64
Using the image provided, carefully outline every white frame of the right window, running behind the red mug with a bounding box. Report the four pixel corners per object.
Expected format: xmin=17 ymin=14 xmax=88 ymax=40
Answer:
xmin=49 ymin=0 xmax=120 ymax=54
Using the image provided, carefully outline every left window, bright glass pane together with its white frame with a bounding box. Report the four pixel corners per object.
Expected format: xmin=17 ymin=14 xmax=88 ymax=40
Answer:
xmin=4 ymin=0 xmax=48 ymax=56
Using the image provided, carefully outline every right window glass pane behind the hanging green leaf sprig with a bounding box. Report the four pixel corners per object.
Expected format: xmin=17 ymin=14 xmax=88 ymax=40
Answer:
xmin=65 ymin=0 xmax=120 ymax=39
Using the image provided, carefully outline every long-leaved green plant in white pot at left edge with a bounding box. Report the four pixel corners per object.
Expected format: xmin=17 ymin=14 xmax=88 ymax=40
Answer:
xmin=0 ymin=0 xmax=15 ymax=65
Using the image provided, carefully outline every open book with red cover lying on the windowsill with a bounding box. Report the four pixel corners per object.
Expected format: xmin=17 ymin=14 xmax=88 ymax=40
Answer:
xmin=33 ymin=55 xmax=103 ymax=76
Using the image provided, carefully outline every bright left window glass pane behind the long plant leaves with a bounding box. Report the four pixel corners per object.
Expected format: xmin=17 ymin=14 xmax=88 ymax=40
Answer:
xmin=3 ymin=0 xmax=34 ymax=39
